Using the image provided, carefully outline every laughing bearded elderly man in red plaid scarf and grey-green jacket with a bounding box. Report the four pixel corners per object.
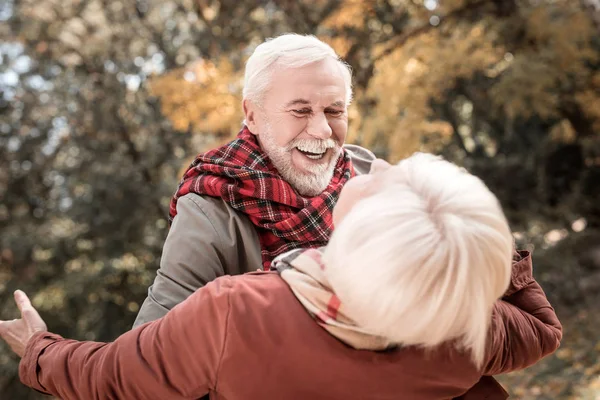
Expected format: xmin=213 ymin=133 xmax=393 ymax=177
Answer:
xmin=134 ymin=34 xmax=374 ymax=326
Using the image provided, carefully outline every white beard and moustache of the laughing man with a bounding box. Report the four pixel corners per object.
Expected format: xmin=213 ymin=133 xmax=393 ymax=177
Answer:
xmin=260 ymin=123 xmax=342 ymax=197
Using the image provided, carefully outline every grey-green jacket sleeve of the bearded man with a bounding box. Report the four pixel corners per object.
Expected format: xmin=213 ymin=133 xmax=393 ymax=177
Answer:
xmin=133 ymin=196 xmax=225 ymax=328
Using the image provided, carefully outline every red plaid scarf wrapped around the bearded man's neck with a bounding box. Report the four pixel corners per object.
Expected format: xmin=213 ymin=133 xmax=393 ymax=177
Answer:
xmin=169 ymin=127 xmax=354 ymax=270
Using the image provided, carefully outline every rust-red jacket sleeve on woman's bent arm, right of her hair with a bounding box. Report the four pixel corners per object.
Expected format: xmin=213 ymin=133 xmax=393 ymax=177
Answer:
xmin=483 ymin=251 xmax=562 ymax=375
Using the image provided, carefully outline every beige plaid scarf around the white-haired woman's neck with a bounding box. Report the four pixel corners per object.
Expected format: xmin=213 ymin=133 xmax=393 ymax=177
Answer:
xmin=273 ymin=249 xmax=393 ymax=350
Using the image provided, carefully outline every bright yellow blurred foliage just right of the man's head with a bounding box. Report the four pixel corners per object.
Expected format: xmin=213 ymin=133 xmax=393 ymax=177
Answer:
xmin=359 ymin=21 xmax=504 ymax=161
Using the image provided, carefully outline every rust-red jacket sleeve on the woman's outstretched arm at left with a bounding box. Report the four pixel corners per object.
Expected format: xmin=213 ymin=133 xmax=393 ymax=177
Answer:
xmin=19 ymin=277 xmax=231 ymax=400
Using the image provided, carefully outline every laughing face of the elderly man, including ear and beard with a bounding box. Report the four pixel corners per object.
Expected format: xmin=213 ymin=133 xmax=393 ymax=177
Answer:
xmin=244 ymin=59 xmax=348 ymax=196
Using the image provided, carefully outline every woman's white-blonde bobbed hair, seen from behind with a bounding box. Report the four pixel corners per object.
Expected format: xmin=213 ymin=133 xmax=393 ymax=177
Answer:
xmin=324 ymin=153 xmax=513 ymax=366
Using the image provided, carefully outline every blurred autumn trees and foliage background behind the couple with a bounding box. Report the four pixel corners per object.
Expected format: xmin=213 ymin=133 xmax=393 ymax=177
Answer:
xmin=0 ymin=0 xmax=600 ymax=399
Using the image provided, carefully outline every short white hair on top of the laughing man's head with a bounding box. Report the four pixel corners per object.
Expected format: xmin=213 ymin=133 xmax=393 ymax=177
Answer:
xmin=243 ymin=33 xmax=352 ymax=106
